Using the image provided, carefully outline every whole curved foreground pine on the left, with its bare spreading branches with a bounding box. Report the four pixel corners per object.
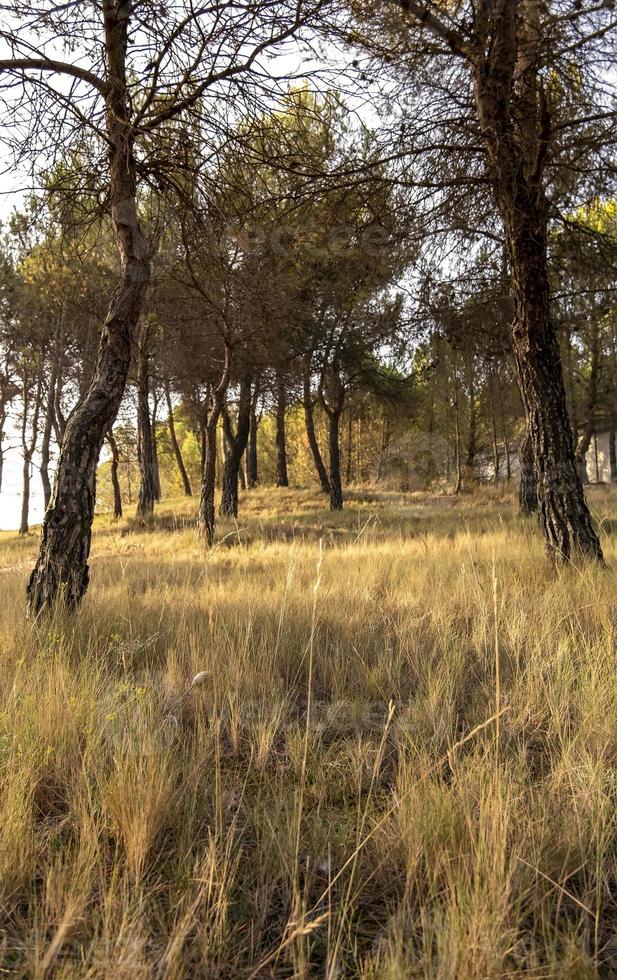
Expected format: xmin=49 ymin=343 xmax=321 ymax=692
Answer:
xmin=0 ymin=0 xmax=332 ymax=615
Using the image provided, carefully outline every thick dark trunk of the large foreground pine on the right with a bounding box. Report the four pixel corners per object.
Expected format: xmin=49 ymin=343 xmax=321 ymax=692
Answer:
xmin=471 ymin=0 xmax=602 ymax=561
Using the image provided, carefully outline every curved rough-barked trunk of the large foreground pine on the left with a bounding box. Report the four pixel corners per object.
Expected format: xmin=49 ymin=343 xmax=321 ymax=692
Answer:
xmin=28 ymin=0 xmax=150 ymax=615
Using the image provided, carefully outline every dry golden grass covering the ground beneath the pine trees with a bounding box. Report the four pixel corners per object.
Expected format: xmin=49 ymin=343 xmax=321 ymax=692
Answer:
xmin=0 ymin=488 xmax=617 ymax=980
